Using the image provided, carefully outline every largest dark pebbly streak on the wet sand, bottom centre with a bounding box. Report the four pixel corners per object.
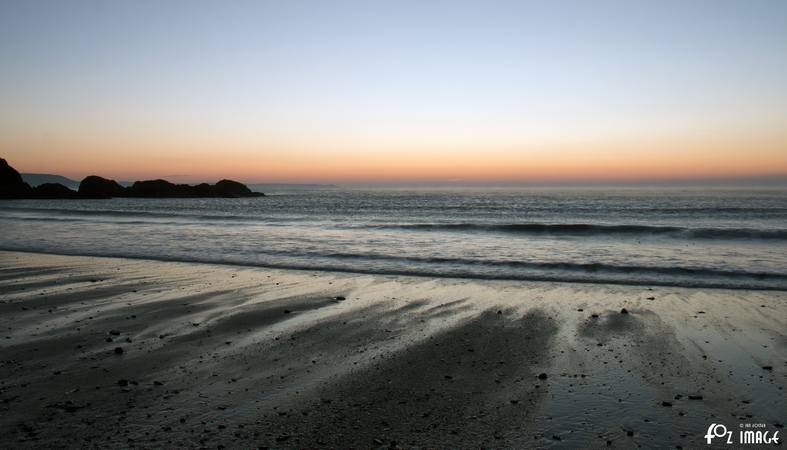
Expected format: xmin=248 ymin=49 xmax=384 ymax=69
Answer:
xmin=265 ymin=310 xmax=557 ymax=448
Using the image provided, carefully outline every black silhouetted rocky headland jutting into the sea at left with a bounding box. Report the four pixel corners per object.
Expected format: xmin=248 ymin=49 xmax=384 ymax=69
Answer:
xmin=0 ymin=158 xmax=265 ymax=199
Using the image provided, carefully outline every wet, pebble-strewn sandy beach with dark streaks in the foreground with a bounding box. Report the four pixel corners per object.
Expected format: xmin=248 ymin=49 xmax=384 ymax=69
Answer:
xmin=0 ymin=252 xmax=787 ymax=449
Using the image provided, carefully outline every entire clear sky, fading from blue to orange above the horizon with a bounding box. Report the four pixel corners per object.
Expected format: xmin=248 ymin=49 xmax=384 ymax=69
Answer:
xmin=0 ymin=0 xmax=787 ymax=183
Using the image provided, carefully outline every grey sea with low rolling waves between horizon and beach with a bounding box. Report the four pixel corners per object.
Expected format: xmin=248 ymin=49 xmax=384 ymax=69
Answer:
xmin=0 ymin=188 xmax=787 ymax=290
